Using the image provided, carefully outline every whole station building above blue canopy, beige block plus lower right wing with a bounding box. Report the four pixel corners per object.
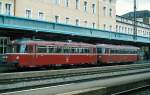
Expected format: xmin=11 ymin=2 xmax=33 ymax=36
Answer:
xmin=0 ymin=0 xmax=150 ymax=54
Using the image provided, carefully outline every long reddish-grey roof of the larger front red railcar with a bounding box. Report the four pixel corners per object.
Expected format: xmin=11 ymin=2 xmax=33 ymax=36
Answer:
xmin=13 ymin=40 xmax=96 ymax=47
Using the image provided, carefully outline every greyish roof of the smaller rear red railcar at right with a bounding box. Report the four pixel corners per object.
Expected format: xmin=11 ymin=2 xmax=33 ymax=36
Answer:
xmin=97 ymin=44 xmax=140 ymax=49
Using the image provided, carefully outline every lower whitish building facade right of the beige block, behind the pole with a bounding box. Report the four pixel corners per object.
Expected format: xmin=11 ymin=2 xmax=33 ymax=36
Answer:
xmin=116 ymin=16 xmax=150 ymax=37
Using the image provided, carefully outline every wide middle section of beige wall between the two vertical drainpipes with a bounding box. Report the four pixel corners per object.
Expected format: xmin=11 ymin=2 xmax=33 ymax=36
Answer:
xmin=15 ymin=0 xmax=98 ymax=28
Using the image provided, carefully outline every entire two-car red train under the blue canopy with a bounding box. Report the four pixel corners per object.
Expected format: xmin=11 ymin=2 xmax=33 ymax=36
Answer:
xmin=6 ymin=40 xmax=139 ymax=68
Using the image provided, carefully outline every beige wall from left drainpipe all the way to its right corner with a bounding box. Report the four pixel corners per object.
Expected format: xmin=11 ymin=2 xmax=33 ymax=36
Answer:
xmin=10 ymin=0 xmax=116 ymax=31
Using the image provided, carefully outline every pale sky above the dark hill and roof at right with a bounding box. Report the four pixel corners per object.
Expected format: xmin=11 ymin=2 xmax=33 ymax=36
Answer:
xmin=116 ymin=0 xmax=150 ymax=15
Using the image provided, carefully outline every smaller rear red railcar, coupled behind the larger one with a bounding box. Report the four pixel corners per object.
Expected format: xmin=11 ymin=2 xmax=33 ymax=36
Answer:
xmin=97 ymin=44 xmax=139 ymax=63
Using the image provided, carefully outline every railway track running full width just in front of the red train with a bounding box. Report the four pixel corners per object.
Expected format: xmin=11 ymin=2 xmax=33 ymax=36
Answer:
xmin=0 ymin=64 xmax=150 ymax=93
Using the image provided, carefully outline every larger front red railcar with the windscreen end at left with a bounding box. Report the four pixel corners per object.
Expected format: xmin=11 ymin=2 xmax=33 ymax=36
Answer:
xmin=6 ymin=40 xmax=97 ymax=67
